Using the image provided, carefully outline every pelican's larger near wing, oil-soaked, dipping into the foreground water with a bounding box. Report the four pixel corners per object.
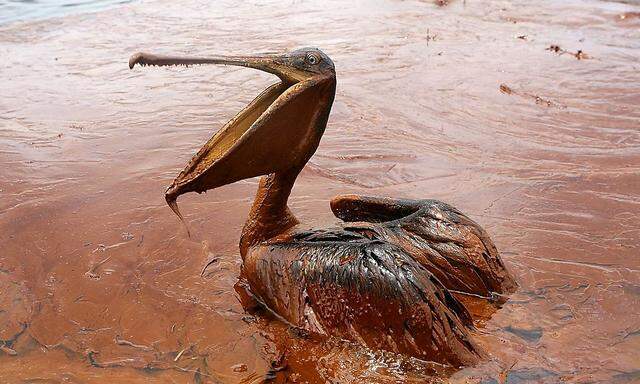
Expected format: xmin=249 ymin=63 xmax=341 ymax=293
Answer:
xmin=243 ymin=234 xmax=481 ymax=365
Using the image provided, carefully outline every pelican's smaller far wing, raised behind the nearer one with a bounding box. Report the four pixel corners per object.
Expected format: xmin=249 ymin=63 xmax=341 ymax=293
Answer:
xmin=331 ymin=195 xmax=516 ymax=297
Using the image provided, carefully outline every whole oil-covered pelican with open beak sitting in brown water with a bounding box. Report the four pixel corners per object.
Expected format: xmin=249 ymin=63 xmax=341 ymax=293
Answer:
xmin=129 ymin=49 xmax=515 ymax=366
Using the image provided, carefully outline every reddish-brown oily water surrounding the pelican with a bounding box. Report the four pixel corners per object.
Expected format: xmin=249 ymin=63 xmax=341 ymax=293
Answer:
xmin=0 ymin=0 xmax=640 ymax=383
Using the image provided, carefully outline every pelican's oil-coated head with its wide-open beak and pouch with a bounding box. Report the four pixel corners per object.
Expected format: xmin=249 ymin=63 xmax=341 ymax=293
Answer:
xmin=129 ymin=48 xmax=336 ymax=216
